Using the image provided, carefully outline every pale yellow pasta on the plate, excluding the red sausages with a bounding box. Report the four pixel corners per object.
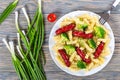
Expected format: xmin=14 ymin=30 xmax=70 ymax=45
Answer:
xmin=53 ymin=14 xmax=110 ymax=71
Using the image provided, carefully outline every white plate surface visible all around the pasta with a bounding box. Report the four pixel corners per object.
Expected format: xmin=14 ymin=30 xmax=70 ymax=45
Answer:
xmin=49 ymin=11 xmax=115 ymax=76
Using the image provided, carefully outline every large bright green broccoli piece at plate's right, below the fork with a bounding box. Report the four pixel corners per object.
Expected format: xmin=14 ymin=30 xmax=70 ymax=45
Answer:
xmin=94 ymin=26 xmax=105 ymax=38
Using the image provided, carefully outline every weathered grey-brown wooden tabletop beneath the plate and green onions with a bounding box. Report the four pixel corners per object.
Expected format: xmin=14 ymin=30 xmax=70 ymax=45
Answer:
xmin=0 ymin=0 xmax=120 ymax=80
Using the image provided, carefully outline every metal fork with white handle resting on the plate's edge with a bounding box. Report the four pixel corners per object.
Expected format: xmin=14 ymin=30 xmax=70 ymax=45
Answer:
xmin=99 ymin=0 xmax=120 ymax=25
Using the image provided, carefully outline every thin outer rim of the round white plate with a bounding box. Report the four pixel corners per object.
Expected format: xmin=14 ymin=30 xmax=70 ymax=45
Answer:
xmin=48 ymin=10 xmax=115 ymax=76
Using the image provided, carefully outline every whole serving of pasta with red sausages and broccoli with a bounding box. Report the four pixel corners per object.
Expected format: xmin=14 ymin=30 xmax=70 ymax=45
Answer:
xmin=53 ymin=14 xmax=110 ymax=71
